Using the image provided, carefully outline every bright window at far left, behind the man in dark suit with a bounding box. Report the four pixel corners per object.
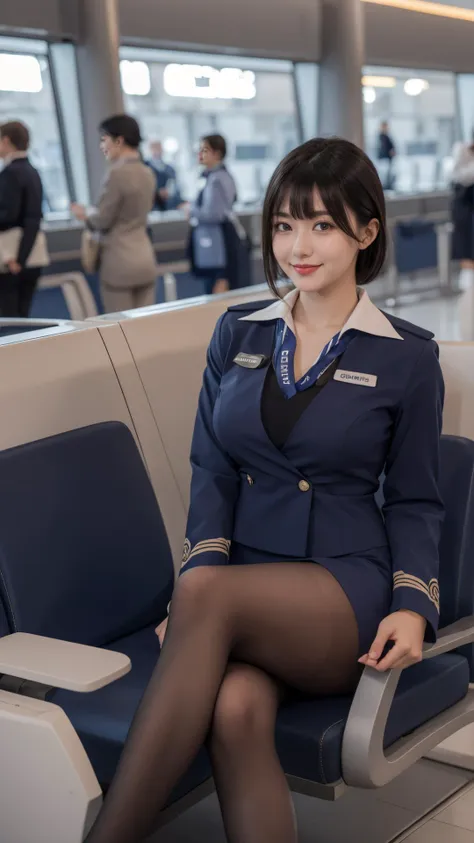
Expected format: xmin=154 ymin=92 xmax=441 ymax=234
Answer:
xmin=0 ymin=37 xmax=70 ymax=211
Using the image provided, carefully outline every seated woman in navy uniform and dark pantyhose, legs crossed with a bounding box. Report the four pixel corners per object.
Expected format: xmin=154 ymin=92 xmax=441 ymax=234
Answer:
xmin=87 ymin=139 xmax=443 ymax=843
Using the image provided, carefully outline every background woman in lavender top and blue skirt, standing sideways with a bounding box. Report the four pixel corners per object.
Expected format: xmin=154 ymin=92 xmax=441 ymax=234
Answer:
xmin=189 ymin=135 xmax=244 ymax=295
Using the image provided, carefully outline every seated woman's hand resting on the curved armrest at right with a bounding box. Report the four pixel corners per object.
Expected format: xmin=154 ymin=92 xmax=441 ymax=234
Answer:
xmin=359 ymin=610 xmax=426 ymax=673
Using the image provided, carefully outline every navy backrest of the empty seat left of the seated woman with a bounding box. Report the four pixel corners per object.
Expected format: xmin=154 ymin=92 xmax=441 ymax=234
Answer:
xmin=0 ymin=422 xmax=173 ymax=646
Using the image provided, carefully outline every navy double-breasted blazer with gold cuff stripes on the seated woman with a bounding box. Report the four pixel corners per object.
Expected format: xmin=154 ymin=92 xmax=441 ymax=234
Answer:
xmin=182 ymin=301 xmax=444 ymax=629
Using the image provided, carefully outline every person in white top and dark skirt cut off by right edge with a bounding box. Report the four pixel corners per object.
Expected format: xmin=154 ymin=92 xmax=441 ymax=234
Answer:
xmin=452 ymin=138 xmax=474 ymax=289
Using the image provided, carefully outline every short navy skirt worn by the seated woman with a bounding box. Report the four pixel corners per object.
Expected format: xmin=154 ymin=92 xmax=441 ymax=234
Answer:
xmin=229 ymin=542 xmax=392 ymax=656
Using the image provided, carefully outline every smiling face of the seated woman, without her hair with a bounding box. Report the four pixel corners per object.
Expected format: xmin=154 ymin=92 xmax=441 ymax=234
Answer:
xmin=272 ymin=189 xmax=379 ymax=293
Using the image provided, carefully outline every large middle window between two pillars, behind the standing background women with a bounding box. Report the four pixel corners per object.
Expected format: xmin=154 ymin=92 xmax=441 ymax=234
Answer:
xmin=121 ymin=47 xmax=300 ymax=205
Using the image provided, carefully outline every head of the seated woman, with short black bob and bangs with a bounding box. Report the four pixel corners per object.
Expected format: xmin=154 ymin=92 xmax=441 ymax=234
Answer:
xmin=262 ymin=138 xmax=387 ymax=296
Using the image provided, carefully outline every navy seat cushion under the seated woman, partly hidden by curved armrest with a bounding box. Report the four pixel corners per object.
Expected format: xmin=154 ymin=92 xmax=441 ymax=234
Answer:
xmin=276 ymin=654 xmax=469 ymax=784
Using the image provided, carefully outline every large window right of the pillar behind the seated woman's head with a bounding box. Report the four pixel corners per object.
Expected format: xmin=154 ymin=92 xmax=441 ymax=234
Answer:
xmin=362 ymin=67 xmax=457 ymax=193
